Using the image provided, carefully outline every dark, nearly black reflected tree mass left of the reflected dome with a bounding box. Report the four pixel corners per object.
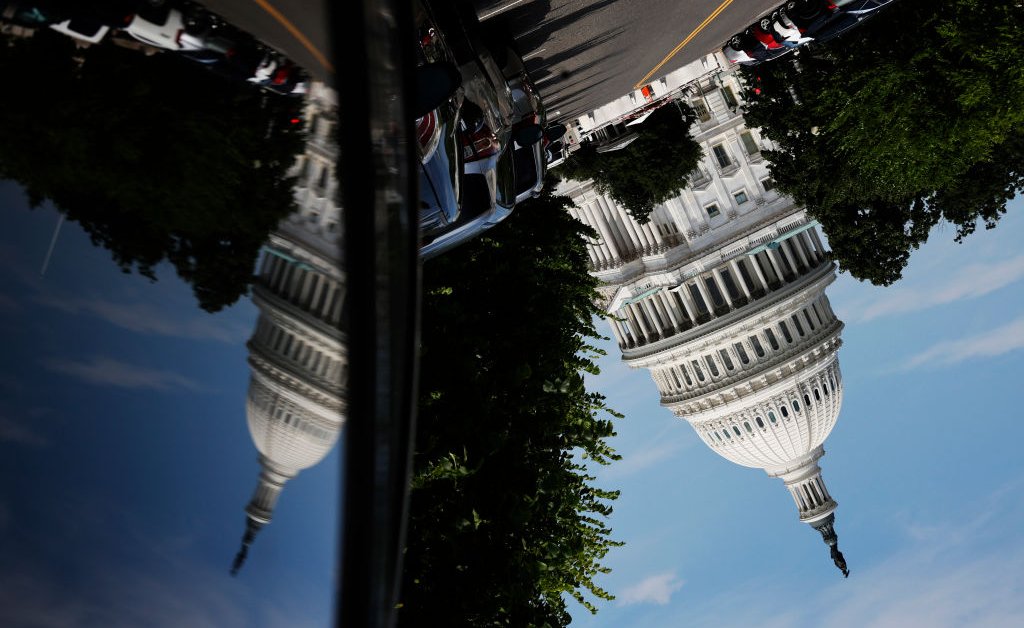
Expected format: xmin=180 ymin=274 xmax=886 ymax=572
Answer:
xmin=0 ymin=29 xmax=302 ymax=311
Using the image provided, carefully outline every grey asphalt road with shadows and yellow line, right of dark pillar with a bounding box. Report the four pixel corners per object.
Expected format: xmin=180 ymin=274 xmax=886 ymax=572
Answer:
xmin=474 ymin=0 xmax=782 ymax=120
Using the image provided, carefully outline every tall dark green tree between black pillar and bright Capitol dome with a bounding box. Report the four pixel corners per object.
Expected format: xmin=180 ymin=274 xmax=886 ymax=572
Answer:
xmin=400 ymin=183 xmax=620 ymax=626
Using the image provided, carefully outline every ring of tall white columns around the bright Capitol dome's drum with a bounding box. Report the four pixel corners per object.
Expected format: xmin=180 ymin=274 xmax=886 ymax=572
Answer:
xmin=611 ymin=228 xmax=827 ymax=348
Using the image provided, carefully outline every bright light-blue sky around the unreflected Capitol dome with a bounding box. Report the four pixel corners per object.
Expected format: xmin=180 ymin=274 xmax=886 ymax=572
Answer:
xmin=574 ymin=198 xmax=1024 ymax=626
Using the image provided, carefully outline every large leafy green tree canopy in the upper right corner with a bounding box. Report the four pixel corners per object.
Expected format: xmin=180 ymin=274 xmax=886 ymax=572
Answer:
xmin=744 ymin=0 xmax=1024 ymax=285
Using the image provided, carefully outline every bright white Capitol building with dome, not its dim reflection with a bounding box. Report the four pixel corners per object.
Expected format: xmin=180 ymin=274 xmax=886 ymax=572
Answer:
xmin=559 ymin=56 xmax=849 ymax=575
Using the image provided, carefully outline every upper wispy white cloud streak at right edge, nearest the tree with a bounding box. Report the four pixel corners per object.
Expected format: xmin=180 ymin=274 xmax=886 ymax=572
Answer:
xmin=844 ymin=255 xmax=1024 ymax=322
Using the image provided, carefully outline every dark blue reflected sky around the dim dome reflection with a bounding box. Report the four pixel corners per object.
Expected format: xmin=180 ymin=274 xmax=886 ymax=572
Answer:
xmin=0 ymin=183 xmax=338 ymax=627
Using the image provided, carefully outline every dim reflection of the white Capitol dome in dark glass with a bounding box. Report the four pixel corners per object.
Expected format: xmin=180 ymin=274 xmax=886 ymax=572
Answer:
xmin=232 ymin=89 xmax=348 ymax=573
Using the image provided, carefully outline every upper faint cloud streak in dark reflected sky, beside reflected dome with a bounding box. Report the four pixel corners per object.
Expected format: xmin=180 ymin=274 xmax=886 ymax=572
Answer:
xmin=34 ymin=295 xmax=250 ymax=343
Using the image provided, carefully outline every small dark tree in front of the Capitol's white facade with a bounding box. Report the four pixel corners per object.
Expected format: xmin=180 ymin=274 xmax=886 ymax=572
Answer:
xmin=560 ymin=102 xmax=703 ymax=223
